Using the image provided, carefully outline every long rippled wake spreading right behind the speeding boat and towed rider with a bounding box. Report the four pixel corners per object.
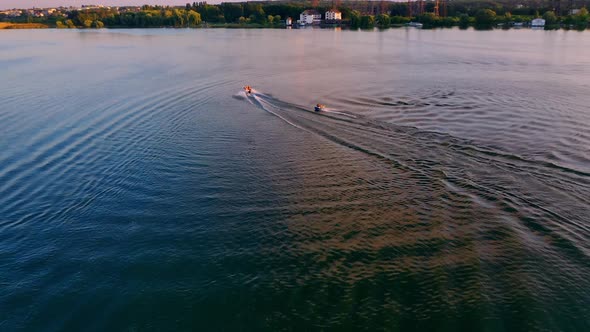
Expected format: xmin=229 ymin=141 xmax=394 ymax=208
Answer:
xmin=240 ymin=89 xmax=590 ymax=257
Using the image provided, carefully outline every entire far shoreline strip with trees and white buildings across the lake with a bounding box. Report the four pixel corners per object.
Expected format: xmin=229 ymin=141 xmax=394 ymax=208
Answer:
xmin=0 ymin=0 xmax=590 ymax=30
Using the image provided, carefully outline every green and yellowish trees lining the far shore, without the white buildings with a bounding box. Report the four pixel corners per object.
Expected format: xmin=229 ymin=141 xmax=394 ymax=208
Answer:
xmin=0 ymin=0 xmax=590 ymax=28
